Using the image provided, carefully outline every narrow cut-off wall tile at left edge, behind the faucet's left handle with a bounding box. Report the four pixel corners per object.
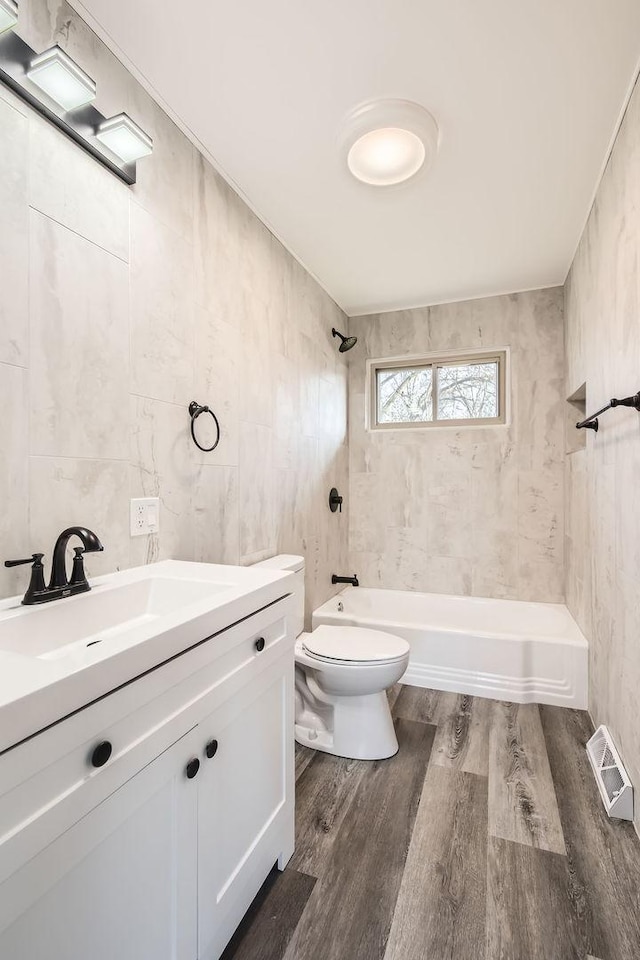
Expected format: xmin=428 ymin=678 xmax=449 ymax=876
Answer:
xmin=0 ymin=363 xmax=28 ymax=597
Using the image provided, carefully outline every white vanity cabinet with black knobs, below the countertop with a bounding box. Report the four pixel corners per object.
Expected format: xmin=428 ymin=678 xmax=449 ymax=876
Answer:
xmin=0 ymin=598 xmax=294 ymax=960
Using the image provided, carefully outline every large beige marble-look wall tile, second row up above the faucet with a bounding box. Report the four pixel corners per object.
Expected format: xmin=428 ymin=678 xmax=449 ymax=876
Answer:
xmin=29 ymin=211 xmax=129 ymax=460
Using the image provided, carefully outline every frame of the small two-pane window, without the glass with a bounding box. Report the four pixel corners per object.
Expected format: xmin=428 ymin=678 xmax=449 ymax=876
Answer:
xmin=365 ymin=347 xmax=511 ymax=431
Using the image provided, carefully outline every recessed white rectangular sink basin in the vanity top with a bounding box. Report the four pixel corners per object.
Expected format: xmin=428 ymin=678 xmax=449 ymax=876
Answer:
xmin=0 ymin=577 xmax=234 ymax=660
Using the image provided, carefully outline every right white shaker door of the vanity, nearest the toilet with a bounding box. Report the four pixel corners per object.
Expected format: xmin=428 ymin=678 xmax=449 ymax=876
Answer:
xmin=198 ymin=656 xmax=294 ymax=960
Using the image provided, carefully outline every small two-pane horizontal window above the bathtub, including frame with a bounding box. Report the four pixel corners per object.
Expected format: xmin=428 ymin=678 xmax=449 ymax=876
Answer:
xmin=370 ymin=350 xmax=506 ymax=428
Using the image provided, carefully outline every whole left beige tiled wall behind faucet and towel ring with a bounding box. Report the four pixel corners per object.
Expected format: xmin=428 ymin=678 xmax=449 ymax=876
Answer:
xmin=0 ymin=0 xmax=348 ymax=624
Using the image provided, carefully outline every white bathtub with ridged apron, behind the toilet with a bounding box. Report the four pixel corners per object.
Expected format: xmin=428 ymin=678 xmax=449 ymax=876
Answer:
xmin=313 ymin=587 xmax=588 ymax=709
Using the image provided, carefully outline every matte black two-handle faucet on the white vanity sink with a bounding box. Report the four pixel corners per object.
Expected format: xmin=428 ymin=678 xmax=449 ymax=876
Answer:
xmin=4 ymin=527 xmax=104 ymax=605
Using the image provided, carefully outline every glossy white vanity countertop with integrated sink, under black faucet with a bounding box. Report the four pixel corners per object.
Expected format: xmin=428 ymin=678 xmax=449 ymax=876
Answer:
xmin=0 ymin=560 xmax=293 ymax=753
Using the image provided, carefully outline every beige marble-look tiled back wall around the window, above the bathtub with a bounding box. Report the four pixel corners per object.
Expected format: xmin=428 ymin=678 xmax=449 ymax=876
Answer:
xmin=349 ymin=288 xmax=564 ymax=601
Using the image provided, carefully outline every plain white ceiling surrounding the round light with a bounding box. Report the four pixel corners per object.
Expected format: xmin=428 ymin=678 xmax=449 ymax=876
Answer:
xmin=72 ymin=0 xmax=640 ymax=315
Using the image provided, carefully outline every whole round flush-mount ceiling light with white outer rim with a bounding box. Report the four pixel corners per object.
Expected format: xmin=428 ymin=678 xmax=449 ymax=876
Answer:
xmin=342 ymin=100 xmax=439 ymax=187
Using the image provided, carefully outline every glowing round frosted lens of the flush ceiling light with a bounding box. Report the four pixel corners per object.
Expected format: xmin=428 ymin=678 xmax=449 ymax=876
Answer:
xmin=347 ymin=127 xmax=425 ymax=186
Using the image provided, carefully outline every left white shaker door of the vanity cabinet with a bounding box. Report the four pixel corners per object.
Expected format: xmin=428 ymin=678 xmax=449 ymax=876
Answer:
xmin=0 ymin=730 xmax=197 ymax=960
